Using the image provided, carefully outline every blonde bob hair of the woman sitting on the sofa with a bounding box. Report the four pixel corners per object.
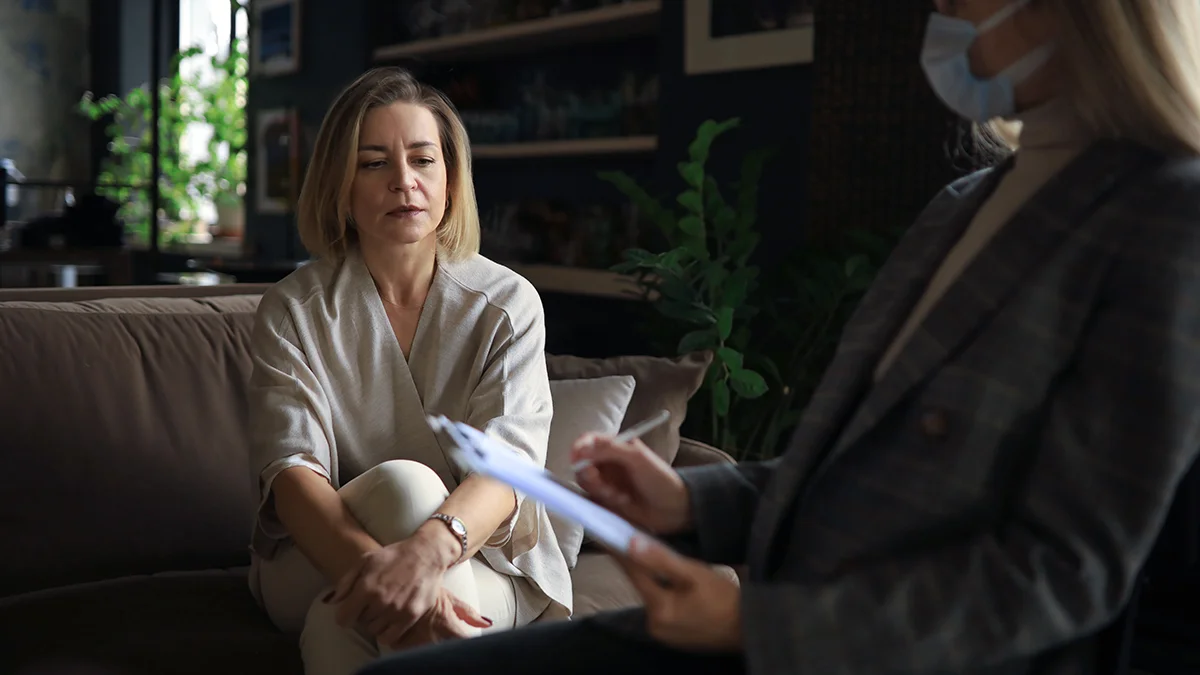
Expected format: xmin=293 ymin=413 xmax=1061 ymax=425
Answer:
xmin=296 ymin=67 xmax=479 ymax=259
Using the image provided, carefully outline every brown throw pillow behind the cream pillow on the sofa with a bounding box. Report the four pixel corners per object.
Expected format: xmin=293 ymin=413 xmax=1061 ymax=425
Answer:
xmin=546 ymin=352 xmax=713 ymax=464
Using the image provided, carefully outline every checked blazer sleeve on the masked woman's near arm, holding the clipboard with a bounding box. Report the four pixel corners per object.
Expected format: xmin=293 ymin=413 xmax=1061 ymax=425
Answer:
xmin=731 ymin=221 xmax=1200 ymax=675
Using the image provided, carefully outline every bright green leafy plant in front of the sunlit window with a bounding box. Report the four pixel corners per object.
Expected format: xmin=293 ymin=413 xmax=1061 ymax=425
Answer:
xmin=78 ymin=33 xmax=248 ymax=245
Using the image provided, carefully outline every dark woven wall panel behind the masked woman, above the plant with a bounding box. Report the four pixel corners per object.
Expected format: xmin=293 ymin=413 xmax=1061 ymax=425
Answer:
xmin=810 ymin=0 xmax=962 ymax=234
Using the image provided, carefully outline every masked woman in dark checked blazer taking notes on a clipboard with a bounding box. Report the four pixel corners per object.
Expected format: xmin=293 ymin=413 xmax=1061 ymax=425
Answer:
xmin=362 ymin=0 xmax=1200 ymax=675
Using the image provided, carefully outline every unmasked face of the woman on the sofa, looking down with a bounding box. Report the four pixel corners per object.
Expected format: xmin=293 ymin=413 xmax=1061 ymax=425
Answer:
xmin=350 ymin=103 xmax=448 ymax=252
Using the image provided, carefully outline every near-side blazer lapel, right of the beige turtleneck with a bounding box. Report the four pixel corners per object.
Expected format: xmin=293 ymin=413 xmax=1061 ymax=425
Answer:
xmin=828 ymin=142 xmax=1148 ymax=454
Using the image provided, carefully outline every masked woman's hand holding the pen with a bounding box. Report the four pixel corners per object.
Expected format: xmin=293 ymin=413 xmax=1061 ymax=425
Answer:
xmin=571 ymin=434 xmax=691 ymax=534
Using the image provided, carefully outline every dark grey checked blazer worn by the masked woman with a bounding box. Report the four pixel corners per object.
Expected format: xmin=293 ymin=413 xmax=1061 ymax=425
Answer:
xmin=682 ymin=142 xmax=1200 ymax=675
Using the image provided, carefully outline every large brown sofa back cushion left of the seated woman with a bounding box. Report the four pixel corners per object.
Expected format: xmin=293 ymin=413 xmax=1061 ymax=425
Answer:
xmin=0 ymin=297 xmax=257 ymax=596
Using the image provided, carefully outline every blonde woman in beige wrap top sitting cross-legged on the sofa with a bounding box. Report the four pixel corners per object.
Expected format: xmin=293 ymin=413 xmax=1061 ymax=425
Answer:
xmin=250 ymin=68 xmax=571 ymax=675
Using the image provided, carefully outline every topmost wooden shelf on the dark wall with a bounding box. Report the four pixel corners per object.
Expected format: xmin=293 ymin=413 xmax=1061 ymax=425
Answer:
xmin=373 ymin=0 xmax=662 ymax=61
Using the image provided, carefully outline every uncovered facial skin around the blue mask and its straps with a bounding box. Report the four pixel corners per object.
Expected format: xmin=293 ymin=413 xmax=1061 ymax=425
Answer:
xmin=934 ymin=0 xmax=1055 ymax=107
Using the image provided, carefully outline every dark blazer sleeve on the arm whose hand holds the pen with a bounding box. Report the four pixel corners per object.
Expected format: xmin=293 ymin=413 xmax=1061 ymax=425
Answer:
xmin=667 ymin=459 xmax=779 ymax=565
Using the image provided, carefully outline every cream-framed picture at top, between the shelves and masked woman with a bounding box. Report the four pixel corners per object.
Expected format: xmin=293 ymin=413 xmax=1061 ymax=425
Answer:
xmin=684 ymin=0 xmax=815 ymax=74
